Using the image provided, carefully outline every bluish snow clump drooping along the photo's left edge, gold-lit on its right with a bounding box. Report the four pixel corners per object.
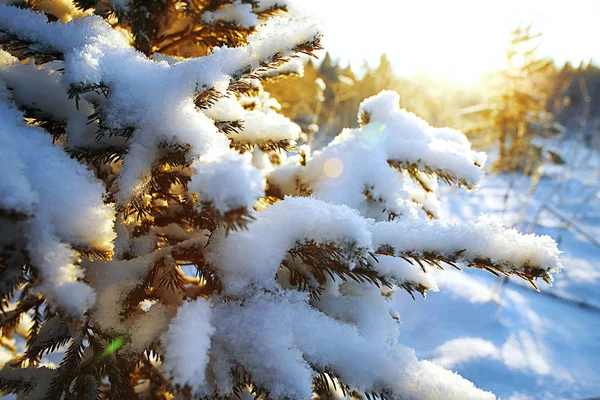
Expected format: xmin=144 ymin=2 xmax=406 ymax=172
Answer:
xmin=0 ymin=84 xmax=115 ymax=314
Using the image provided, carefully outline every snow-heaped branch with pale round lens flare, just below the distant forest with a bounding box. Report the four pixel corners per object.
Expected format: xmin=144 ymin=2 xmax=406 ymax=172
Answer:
xmin=267 ymin=91 xmax=486 ymax=219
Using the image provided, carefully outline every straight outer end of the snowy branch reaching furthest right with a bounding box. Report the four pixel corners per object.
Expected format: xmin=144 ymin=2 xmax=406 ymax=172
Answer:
xmin=372 ymin=216 xmax=561 ymax=288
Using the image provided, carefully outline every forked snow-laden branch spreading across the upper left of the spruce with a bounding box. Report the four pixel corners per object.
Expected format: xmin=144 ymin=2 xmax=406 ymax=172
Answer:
xmin=0 ymin=6 xmax=318 ymax=216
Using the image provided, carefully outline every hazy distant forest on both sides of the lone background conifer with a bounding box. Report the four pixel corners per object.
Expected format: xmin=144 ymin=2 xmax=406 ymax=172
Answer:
xmin=265 ymin=54 xmax=600 ymax=148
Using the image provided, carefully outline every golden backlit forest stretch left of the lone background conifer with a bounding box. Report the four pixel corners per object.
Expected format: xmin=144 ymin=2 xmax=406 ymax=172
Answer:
xmin=264 ymin=54 xmax=468 ymax=148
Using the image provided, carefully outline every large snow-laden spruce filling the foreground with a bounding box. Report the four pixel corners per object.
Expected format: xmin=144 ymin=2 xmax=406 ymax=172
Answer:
xmin=0 ymin=0 xmax=560 ymax=399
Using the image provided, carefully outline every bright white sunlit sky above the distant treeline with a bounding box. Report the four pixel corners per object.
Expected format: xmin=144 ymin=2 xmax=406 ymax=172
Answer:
xmin=302 ymin=0 xmax=600 ymax=83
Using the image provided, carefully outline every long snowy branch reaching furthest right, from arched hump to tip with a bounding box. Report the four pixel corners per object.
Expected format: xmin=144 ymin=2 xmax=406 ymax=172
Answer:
xmin=207 ymin=198 xmax=561 ymax=295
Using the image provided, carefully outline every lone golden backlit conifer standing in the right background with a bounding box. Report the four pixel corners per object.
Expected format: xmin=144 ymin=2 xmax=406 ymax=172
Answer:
xmin=469 ymin=25 xmax=559 ymax=173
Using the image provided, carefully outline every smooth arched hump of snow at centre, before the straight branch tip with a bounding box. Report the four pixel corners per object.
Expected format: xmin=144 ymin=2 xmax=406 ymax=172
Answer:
xmin=207 ymin=197 xmax=370 ymax=294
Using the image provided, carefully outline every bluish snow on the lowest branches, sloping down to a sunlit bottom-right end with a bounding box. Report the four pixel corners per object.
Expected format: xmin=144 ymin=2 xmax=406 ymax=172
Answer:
xmin=213 ymin=292 xmax=494 ymax=399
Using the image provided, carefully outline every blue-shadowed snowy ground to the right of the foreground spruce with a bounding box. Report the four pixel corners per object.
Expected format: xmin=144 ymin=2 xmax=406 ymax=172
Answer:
xmin=396 ymin=142 xmax=600 ymax=400
